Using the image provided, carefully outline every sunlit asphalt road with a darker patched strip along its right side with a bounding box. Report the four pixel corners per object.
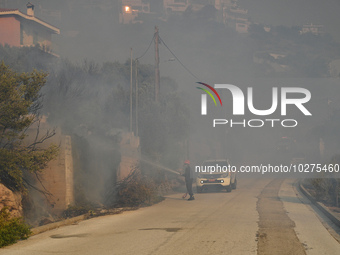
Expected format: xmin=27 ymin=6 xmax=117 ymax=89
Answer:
xmin=0 ymin=179 xmax=340 ymax=255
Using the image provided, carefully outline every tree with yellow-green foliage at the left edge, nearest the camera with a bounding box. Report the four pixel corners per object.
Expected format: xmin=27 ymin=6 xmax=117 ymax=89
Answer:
xmin=0 ymin=62 xmax=58 ymax=192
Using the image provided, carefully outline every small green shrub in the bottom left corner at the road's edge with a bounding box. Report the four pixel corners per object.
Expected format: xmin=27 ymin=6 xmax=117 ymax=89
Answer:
xmin=0 ymin=207 xmax=31 ymax=248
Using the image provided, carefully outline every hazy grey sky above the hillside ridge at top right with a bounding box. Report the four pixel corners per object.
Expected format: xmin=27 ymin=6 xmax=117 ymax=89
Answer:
xmin=238 ymin=0 xmax=340 ymax=42
